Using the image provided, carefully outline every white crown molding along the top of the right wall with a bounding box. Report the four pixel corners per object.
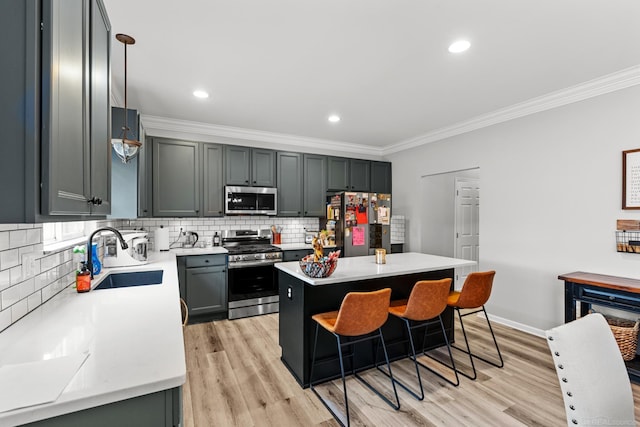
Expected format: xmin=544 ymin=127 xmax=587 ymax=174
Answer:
xmin=382 ymin=65 xmax=640 ymax=156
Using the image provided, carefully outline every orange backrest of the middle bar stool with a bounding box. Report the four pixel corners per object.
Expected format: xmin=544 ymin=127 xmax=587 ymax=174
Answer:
xmin=403 ymin=279 xmax=451 ymax=321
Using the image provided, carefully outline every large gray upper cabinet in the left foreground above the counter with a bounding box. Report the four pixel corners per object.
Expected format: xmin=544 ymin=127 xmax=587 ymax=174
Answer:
xmin=0 ymin=0 xmax=111 ymax=222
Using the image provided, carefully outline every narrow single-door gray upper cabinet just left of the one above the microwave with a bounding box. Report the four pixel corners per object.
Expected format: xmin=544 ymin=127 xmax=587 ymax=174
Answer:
xmin=202 ymin=144 xmax=224 ymax=216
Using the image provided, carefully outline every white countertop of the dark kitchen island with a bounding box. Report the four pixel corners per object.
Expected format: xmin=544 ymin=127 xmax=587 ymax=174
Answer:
xmin=274 ymin=252 xmax=476 ymax=286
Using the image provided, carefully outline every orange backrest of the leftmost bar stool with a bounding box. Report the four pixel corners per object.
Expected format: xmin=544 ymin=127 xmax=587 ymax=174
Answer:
xmin=334 ymin=288 xmax=391 ymax=337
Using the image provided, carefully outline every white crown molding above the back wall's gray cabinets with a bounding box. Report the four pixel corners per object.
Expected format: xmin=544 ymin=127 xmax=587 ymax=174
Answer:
xmin=140 ymin=114 xmax=382 ymax=158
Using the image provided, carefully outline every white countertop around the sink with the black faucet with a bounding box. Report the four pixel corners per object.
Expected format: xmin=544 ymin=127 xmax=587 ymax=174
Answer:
xmin=0 ymin=252 xmax=186 ymax=426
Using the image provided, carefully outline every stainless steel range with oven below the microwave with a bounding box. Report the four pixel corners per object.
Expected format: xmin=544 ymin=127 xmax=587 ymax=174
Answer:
xmin=222 ymin=230 xmax=282 ymax=319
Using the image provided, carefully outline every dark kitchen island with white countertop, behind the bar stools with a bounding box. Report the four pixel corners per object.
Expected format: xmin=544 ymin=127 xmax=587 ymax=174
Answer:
xmin=275 ymin=252 xmax=476 ymax=387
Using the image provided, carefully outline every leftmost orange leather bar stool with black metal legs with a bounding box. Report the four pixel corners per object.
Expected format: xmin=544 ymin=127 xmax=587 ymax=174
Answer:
xmin=309 ymin=288 xmax=400 ymax=426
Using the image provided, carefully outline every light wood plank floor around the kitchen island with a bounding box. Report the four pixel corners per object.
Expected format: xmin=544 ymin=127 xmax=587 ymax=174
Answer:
xmin=184 ymin=314 xmax=640 ymax=427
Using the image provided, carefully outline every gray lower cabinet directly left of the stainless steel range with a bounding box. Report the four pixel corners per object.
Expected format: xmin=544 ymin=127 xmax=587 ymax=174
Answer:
xmin=178 ymin=255 xmax=227 ymax=317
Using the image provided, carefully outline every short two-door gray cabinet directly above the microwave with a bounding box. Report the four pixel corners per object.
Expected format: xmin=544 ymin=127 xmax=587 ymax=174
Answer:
xmin=225 ymin=145 xmax=276 ymax=187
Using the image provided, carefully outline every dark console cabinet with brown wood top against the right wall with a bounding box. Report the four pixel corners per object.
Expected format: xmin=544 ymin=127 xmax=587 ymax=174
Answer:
xmin=558 ymin=271 xmax=640 ymax=383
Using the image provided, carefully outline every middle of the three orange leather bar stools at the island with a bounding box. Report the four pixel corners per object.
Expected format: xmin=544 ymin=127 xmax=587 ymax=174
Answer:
xmin=383 ymin=279 xmax=460 ymax=400
